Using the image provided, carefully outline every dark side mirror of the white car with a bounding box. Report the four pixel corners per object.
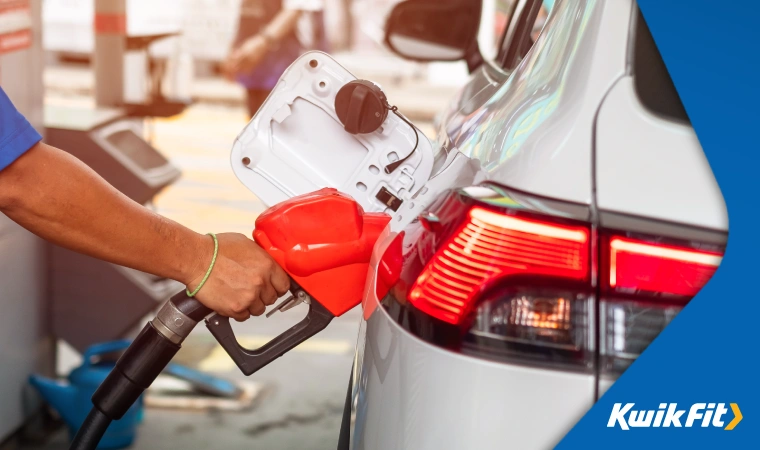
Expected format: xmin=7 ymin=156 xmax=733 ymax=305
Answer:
xmin=385 ymin=0 xmax=483 ymax=72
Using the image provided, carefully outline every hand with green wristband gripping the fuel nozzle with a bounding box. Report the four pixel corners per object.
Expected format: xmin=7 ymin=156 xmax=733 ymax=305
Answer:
xmin=187 ymin=233 xmax=290 ymax=322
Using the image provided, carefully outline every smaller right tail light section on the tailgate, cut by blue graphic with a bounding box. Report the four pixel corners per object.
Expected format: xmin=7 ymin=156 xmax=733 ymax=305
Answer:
xmin=600 ymin=232 xmax=723 ymax=378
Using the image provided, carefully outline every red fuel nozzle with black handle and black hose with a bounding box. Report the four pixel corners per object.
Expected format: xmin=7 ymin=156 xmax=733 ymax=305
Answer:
xmin=70 ymin=188 xmax=390 ymax=450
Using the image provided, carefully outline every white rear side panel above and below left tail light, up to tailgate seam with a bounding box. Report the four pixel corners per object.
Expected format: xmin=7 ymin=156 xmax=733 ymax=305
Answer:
xmin=351 ymin=0 xmax=633 ymax=449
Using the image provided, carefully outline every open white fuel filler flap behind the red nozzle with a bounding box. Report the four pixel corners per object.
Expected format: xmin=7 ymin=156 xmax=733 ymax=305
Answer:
xmin=231 ymin=52 xmax=433 ymax=216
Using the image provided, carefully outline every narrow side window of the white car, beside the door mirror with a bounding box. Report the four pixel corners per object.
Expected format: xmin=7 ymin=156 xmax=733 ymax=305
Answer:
xmin=497 ymin=0 xmax=554 ymax=72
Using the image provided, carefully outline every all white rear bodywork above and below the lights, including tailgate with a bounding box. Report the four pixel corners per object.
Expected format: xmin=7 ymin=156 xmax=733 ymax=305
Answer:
xmin=351 ymin=0 xmax=727 ymax=449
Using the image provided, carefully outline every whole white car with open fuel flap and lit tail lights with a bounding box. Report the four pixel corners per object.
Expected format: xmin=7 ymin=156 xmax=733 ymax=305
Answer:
xmin=232 ymin=0 xmax=728 ymax=450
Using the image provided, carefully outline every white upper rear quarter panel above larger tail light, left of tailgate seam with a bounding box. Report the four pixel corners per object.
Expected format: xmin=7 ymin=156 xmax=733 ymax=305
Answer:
xmin=442 ymin=0 xmax=632 ymax=204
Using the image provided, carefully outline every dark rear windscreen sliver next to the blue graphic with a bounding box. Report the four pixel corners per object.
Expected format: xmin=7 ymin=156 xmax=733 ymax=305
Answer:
xmin=633 ymin=11 xmax=689 ymax=122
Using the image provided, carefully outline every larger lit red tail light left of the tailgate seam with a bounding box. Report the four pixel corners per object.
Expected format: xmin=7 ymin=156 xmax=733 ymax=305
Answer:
xmin=380 ymin=187 xmax=594 ymax=370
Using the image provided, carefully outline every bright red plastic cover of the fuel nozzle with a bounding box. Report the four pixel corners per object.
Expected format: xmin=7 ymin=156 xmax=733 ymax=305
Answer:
xmin=253 ymin=188 xmax=390 ymax=317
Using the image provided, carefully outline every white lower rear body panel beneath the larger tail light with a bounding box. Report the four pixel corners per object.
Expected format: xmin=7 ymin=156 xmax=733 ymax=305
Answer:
xmin=352 ymin=302 xmax=596 ymax=450
